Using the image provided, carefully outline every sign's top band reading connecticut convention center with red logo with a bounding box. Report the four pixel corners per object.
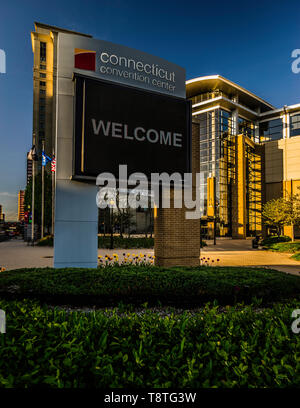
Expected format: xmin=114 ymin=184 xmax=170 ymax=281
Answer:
xmin=58 ymin=33 xmax=186 ymax=98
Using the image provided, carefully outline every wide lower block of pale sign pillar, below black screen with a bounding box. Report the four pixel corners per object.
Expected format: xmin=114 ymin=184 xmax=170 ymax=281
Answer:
xmin=54 ymin=180 xmax=98 ymax=268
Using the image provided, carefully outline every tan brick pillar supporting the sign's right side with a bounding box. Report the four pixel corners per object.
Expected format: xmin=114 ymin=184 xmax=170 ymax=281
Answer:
xmin=154 ymin=123 xmax=200 ymax=267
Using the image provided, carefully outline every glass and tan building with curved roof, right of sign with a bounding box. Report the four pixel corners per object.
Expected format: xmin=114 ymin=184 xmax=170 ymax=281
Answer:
xmin=186 ymin=75 xmax=300 ymax=238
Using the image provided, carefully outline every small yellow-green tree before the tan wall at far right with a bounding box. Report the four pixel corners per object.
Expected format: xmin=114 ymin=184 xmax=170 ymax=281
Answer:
xmin=262 ymin=197 xmax=286 ymax=236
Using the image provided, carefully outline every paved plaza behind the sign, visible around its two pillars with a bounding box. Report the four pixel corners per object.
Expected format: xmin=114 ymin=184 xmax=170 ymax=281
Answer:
xmin=0 ymin=239 xmax=300 ymax=275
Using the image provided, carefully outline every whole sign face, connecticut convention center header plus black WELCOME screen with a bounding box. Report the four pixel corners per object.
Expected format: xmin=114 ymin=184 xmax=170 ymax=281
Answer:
xmin=59 ymin=34 xmax=191 ymax=180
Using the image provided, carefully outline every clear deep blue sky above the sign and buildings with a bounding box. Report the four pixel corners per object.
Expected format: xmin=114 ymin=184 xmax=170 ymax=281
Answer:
xmin=0 ymin=0 xmax=300 ymax=219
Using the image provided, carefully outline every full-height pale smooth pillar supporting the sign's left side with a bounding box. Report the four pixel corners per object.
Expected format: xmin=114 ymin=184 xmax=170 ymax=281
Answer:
xmin=54 ymin=44 xmax=98 ymax=268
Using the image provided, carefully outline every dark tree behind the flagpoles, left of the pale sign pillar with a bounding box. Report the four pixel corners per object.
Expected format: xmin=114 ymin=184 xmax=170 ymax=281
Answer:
xmin=24 ymin=171 xmax=52 ymax=231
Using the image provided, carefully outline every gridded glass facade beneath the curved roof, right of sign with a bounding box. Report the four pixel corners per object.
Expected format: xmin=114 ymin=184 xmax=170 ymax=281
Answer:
xmin=194 ymin=108 xmax=261 ymax=237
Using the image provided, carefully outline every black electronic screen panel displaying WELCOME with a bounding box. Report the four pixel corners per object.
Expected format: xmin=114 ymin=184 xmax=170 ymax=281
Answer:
xmin=74 ymin=75 xmax=191 ymax=179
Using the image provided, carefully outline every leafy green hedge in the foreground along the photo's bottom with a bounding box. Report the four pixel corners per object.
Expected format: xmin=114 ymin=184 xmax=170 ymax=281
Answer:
xmin=0 ymin=300 xmax=300 ymax=388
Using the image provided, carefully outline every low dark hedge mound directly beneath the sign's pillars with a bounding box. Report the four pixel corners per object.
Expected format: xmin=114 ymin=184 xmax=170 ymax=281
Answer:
xmin=0 ymin=265 xmax=300 ymax=305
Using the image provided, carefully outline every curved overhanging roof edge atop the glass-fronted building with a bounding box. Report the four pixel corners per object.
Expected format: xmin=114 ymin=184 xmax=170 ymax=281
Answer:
xmin=186 ymin=75 xmax=275 ymax=112
